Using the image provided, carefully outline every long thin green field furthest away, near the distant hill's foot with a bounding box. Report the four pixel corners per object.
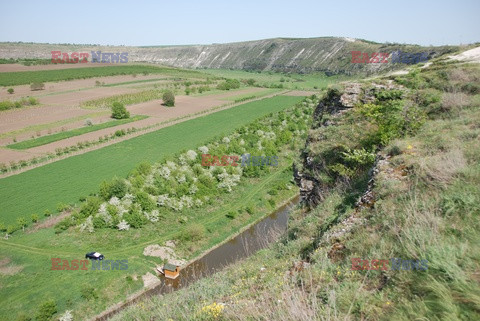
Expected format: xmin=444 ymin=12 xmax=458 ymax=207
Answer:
xmin=0 ymin=65 xmax=207 ymax=86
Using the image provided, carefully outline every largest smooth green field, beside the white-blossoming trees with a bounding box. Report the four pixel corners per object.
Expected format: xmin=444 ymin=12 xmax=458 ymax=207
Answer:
xmin=0 ymin=96 xmax=302 ymax=224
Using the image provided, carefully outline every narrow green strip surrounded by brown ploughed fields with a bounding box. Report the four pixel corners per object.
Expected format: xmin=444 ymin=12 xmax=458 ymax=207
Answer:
xmin=7 ymin=115 xmax=148 ymax=149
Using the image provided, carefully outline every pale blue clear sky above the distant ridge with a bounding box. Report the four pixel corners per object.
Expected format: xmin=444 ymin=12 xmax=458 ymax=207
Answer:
xmin=0 ymin=0 xmax=480 ymax=46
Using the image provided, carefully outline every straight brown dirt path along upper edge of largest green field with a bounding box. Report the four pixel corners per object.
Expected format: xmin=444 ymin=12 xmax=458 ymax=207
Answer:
xmin=0 ymin=90 xmax=290 ymax=178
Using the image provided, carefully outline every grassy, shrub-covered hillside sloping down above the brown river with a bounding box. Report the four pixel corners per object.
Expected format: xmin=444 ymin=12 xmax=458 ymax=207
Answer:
xmin=109 ymin=61 xmax=480 ymax=320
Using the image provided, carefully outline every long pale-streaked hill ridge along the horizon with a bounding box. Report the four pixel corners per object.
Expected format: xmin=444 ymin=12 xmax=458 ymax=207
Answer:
xmin=0 ymin=37 xmax=459 ymax=75
